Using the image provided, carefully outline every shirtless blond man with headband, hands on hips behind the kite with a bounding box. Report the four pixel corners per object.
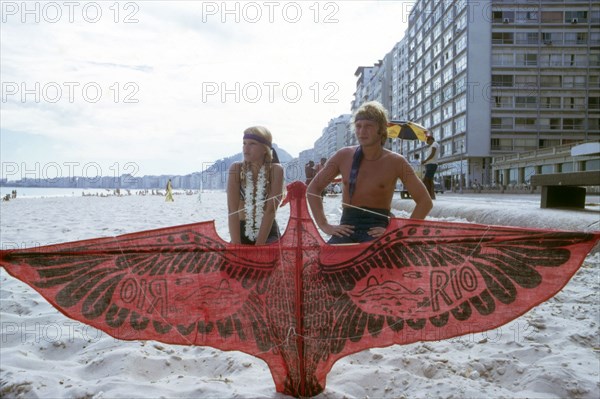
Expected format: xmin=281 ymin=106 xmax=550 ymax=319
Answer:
xmin=307 ymin=101 xmax=433 ymax=244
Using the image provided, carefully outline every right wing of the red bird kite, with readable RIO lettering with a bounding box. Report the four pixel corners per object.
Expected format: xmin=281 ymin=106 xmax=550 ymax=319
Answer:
xmin=304 ymin=219 xmax=600 ymax=396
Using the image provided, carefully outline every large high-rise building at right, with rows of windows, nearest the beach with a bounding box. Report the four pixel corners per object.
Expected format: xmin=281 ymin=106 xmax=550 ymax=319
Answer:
xmin=391 ymin=0 xmax=600 ymax=187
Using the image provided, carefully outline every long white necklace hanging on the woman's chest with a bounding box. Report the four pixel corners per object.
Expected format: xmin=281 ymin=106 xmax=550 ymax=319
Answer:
xmin=244 ymin=165 xmax=267 ymax=241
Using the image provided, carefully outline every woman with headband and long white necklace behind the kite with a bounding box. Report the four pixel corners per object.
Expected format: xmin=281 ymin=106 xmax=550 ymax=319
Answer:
xmin=227 ymin=126 xmax=283 ymax=245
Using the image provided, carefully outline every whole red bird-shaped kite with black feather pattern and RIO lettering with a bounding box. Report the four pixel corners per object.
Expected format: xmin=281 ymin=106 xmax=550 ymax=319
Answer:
xmin=0 ymin=182 xmax=600 ymax=397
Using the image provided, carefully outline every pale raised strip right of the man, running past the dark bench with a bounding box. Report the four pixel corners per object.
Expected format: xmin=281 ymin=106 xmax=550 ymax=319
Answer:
xmin=392 ymin=192 xmax=600 ymax=231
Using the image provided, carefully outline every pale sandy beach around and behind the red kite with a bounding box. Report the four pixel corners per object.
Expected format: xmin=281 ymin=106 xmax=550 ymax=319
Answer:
xmin=0 ymin=192 xmax=600 ymax=399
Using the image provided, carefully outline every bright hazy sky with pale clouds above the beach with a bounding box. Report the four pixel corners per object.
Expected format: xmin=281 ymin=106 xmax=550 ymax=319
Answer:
xmin=0 ymin=1 xmax=413 ymax=180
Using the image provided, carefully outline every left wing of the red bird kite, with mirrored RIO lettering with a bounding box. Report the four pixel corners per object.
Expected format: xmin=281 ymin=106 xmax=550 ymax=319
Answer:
xmin=0 ymin=222 xmax=286 ymax=366
